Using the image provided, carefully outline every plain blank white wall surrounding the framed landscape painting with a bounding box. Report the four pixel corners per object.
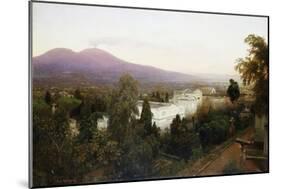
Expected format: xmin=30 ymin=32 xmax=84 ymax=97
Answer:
xmin=0 ymin=0 xmax=281 ymax=189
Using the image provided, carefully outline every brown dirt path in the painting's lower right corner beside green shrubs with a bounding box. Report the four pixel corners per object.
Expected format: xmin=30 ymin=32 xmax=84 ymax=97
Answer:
xmin=179 ymin=128 xmax=260 ymax=176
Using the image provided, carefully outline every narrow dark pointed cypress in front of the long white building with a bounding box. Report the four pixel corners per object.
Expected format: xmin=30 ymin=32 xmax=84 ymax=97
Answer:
xmin=140 ymin=98 xmax=152 ymax=136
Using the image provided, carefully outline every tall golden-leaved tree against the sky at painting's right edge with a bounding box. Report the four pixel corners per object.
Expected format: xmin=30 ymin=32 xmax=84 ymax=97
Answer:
xmin=235 ymin=34 xmax=269 ymax=115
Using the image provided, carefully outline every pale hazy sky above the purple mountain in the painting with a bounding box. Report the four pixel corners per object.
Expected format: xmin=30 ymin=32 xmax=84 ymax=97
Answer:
xmin=33 ymin=3 xmax=267 ymax=74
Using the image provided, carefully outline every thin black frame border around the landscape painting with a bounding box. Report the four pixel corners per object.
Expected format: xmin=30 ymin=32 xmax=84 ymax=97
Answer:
xmin=28 ymin=0 xmax=270 ymax=188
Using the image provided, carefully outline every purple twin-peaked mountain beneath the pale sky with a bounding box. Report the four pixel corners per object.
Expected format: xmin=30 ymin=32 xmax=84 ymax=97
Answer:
xmin=32 ymin=48 xmax=198 ymax=84
